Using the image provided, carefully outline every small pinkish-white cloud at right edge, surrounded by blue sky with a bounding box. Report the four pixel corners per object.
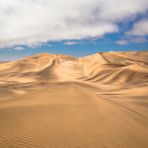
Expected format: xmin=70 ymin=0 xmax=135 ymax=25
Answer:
xmin=126 ymin=19 xmax=148 ymax=36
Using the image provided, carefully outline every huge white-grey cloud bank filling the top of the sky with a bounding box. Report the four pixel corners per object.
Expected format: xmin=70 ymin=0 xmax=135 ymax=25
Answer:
xmin=0 ymin=0 xmax=148 ymax=48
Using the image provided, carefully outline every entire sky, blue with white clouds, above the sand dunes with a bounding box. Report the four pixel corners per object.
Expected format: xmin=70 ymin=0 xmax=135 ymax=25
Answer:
xmin=0 ymin=0 xmax=148 ymax=61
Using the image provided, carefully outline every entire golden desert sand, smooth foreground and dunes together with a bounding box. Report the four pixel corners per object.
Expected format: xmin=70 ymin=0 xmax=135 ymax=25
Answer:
xmin=0 ymin=51 xmax=148 ymax=148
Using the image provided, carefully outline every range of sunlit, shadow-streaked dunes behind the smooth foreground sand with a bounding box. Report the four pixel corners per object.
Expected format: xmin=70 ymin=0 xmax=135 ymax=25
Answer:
xmin=0 ymin=52 xmax=148 ymax=84
